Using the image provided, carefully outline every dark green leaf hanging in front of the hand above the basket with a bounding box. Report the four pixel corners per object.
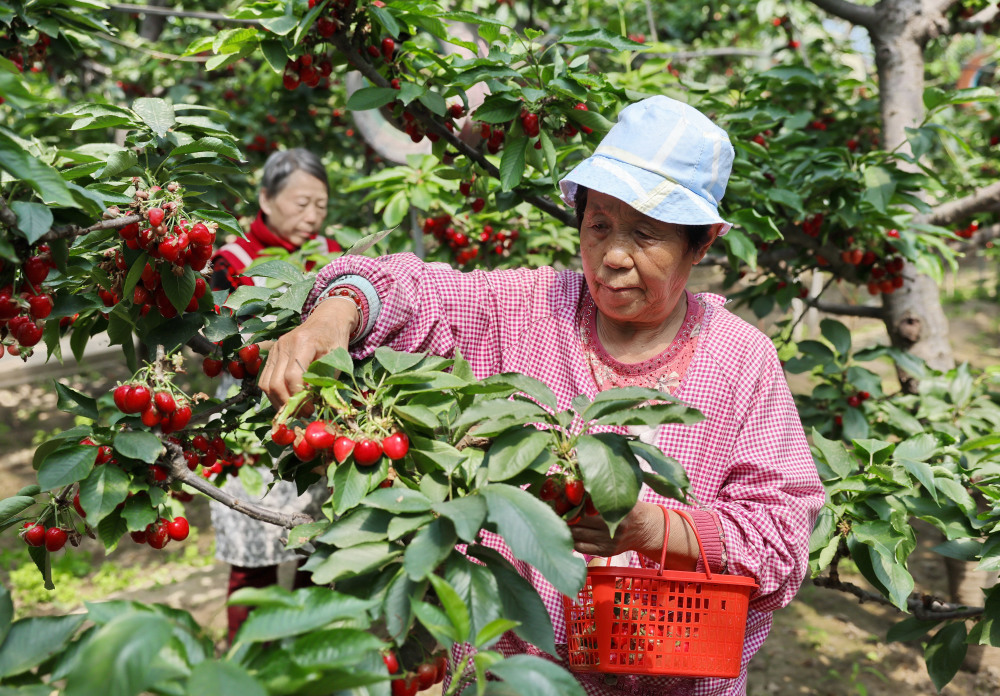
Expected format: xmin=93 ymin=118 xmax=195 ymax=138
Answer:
xmin=580 ymin=433 xmax=642 ymax=532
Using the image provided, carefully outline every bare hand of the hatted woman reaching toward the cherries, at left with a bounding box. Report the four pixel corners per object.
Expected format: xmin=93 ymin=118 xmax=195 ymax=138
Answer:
xmin=257 ymin=297 xmax=359 ymax=409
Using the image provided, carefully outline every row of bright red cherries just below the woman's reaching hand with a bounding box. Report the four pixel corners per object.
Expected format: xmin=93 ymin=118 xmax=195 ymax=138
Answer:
xmin=271 ymin=419 xmax=410 ymax=467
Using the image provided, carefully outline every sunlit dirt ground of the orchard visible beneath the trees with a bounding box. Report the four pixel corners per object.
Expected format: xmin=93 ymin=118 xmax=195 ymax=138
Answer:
xmin=0 ymin=290 xmax=1000 ymax=696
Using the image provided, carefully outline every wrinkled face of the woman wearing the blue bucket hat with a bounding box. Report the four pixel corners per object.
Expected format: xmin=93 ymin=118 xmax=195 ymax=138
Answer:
xmin=580 ymin=190 xmax=716 ymax=327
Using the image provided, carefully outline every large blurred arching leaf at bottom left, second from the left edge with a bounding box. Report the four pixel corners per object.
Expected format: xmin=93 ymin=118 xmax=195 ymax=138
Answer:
xmin=65 ymin=611 xmax=171 ymax=696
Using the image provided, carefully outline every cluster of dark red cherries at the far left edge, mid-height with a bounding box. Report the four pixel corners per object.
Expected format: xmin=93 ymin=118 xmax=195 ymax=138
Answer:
xmin=0 ymin=244 xmax=55 ymax=357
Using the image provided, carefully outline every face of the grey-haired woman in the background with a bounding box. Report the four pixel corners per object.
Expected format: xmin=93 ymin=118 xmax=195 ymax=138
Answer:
xmin=258 ymin=169 xmax=328 ymax=247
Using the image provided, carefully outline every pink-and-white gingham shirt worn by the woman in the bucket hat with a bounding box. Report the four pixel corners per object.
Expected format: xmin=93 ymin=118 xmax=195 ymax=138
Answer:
xmin=305 ymin=254 xmax=824 ymax=696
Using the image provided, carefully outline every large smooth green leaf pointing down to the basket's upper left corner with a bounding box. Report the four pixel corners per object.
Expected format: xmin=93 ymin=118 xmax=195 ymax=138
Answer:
xmin=480 ymin=483 xmax=587 ymax=595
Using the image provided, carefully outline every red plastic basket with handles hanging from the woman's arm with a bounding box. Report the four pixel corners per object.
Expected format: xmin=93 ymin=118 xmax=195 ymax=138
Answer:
xmin=563 ymin=508 xmax=757 ymax=678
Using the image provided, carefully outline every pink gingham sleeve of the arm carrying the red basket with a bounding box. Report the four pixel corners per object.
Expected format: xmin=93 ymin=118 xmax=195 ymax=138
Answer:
xmin=711 ymin=340 xmax=824 ymax=611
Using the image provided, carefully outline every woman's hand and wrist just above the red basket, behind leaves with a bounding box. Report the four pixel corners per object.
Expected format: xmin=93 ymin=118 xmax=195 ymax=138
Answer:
xmin=569 ymin=501 xmax=698 ymax=570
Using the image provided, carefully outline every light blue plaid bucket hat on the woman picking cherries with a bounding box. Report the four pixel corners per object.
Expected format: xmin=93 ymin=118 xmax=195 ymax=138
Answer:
xmin=559 ymin=96 xmax=735 ymax=234
